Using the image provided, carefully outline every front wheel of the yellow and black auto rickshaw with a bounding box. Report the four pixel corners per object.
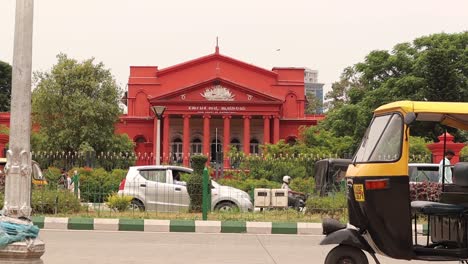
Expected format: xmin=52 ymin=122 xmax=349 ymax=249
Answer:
xmin=325 ymin=245 xmax=369 ymax=264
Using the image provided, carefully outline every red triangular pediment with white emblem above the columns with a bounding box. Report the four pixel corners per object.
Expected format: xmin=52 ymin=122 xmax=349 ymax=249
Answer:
xmin=150 ymin=79 xmax=282 ymax=103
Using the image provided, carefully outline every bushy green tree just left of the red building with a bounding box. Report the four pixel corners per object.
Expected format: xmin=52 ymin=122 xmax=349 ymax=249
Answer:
xmin=32 ymin=54 xmax=133 ymax=157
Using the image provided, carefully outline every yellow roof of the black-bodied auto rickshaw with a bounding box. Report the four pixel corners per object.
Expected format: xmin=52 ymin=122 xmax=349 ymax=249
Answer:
xmin=374 ymin=101 xmax=468 ymax=130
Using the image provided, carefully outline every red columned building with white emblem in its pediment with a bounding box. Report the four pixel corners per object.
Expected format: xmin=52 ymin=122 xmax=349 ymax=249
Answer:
xmin=116 ymin=47 xmax=323 ymax=168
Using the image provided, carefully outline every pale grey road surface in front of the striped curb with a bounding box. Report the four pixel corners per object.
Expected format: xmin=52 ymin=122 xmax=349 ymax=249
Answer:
xmin=40 ymin=230 xmax=457 ymax=264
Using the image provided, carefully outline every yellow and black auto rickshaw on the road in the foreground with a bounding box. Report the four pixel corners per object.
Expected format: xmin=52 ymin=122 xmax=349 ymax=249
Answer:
xmin=320 ymin=101 xmax=468 ymax=264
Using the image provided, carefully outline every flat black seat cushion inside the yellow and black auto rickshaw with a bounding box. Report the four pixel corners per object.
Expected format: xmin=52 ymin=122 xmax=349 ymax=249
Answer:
xmin=411 ymin=201 xmax=465 ymax=215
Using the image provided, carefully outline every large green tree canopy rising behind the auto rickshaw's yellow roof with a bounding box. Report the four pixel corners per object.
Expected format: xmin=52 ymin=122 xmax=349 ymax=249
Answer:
xmin=320 ymin=32 xmax=468 ymax=146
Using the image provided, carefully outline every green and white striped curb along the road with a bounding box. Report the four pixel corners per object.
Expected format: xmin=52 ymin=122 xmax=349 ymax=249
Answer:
xmin=32 ymin=216 xmax=423 ymax=235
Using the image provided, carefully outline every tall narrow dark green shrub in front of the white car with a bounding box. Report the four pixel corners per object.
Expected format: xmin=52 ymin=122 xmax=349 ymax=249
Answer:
xmin=187 ymin=155 xmax=208 ymax=212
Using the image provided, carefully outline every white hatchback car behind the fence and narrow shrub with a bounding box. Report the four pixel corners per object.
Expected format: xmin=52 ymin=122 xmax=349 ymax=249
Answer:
xmin=118 ymin=165 xmax=253 ymax=212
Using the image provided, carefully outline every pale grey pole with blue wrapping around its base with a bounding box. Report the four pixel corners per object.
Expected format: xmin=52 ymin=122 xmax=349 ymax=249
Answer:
xmin=0 ymin=0 xmax=45 ymax=263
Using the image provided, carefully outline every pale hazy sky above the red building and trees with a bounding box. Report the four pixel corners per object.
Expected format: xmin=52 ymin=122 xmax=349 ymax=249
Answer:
xmin=0 ymin=0 xmax=468 ymax=94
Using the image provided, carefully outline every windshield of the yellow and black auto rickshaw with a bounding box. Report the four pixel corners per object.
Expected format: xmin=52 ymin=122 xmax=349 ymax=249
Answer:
xmin=353 ymin=113 xmax=403 ymax=163
